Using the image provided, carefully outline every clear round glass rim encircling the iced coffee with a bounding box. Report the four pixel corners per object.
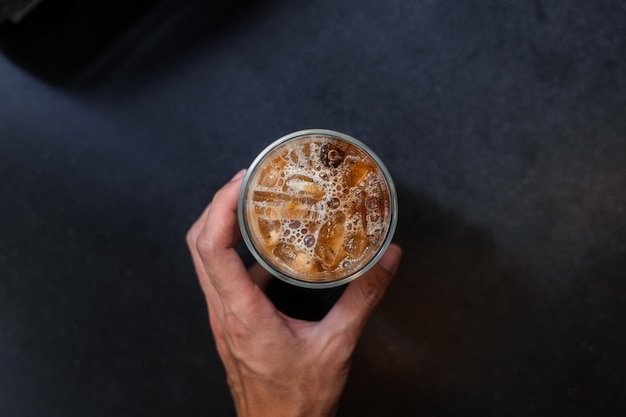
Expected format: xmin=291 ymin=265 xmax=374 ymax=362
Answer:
xmin=237 ymin=129 xmax=398 ymax=289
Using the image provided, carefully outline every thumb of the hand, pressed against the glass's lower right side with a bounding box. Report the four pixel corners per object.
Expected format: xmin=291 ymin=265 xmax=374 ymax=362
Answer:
xmin=323 ymin=243 xmax=402 ymax=342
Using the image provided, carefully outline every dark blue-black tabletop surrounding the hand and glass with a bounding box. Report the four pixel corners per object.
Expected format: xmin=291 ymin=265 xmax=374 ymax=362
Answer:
xmin=0 ymin=0 xmax=626 ymax=417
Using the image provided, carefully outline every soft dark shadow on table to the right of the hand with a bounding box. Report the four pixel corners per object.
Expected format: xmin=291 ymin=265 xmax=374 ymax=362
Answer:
xmin=339 ymin=186 xmax=529 ymax=416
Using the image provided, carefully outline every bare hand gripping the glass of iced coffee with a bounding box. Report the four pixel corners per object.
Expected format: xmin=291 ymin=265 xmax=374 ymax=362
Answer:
xmin=187 ymin=171 xmax=401 ymax=417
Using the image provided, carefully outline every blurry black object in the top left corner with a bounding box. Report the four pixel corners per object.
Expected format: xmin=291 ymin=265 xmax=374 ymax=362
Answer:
xmin=0 ymin=0 xmax=263 ymax=89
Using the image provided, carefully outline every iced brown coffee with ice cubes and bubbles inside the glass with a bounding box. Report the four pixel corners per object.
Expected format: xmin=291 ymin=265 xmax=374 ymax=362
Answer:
xmin=245 ymin=135 xmax=391 ymax=282
